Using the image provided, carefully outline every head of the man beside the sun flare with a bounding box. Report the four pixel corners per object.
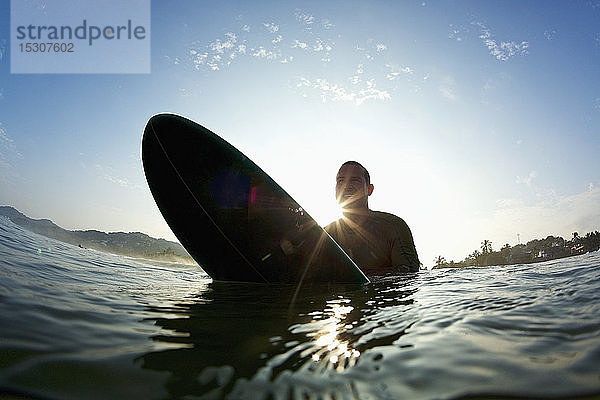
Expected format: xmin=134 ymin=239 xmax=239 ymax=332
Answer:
xmin=335 ymin=161 xmax=374 ymax=210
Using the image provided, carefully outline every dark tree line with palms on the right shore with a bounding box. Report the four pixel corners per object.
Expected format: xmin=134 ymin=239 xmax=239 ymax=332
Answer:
xmin=433 ymin=231 xmax=600 ymax=268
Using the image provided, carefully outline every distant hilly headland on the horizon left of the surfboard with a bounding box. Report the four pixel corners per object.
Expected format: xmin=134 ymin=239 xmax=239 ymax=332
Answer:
xmin=0 ymin=206 xmax=195 ymax=264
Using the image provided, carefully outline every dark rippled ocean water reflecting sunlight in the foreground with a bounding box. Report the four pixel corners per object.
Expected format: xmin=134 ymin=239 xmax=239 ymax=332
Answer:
xmin=0 ymin=219 xmax=600 ymax=400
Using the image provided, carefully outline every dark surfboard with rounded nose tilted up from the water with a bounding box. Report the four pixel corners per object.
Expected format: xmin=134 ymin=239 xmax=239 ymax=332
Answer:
xmin=142 ymin=114 xmax=369 ymax=284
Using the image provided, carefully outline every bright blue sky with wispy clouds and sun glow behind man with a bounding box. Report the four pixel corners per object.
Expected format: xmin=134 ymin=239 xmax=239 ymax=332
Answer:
xmin=0 ymin=0 xmax=600 ymax=266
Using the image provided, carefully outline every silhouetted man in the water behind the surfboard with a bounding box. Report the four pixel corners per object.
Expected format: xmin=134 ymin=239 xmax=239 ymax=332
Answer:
xmin=325 ymin=161 xmax=420 ymax=276
